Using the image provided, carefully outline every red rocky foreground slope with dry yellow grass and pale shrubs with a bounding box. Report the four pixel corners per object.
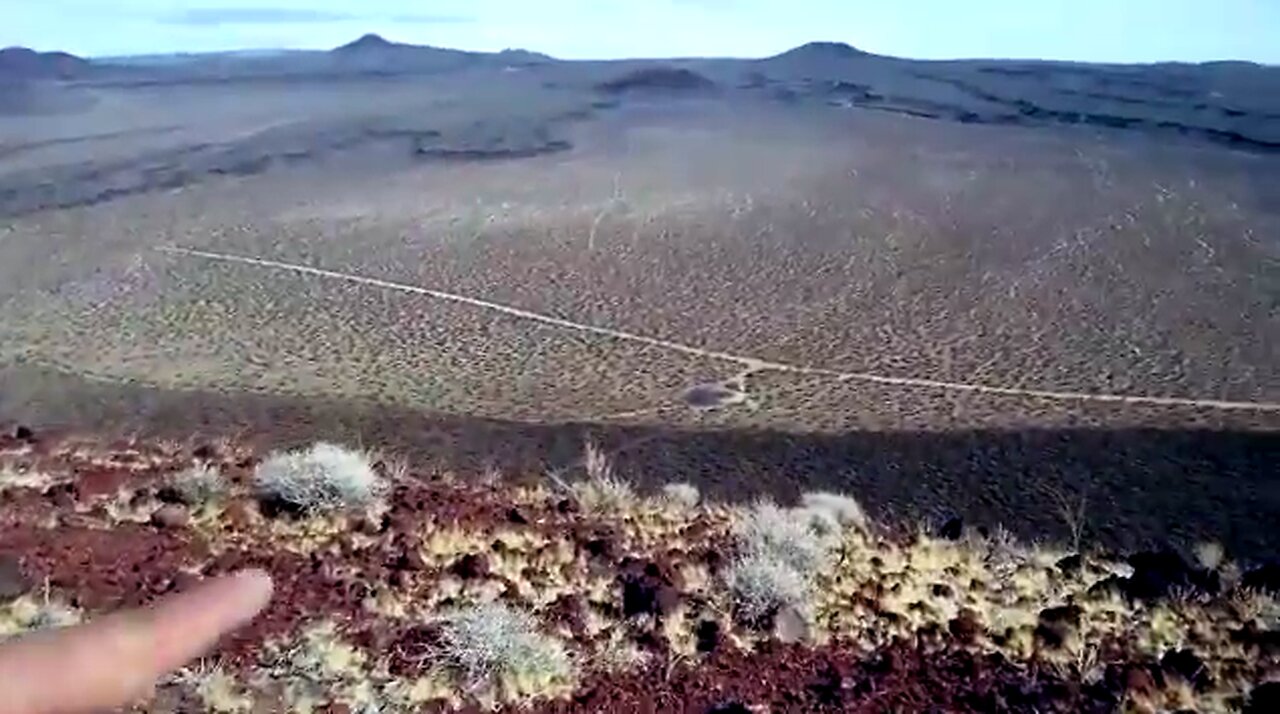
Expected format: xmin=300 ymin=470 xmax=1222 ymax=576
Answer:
xmin=0 ymin=432 xmax=1280 ymax=711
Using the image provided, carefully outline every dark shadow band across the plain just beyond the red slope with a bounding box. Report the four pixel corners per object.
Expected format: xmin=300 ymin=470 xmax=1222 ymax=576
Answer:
xmin=0 ymin=367 xmax=1280 ymax=560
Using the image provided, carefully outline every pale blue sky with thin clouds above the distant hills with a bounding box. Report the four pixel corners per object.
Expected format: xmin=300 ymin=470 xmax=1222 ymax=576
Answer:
xmin=0 ymin=0 xmax=1280 ymax=64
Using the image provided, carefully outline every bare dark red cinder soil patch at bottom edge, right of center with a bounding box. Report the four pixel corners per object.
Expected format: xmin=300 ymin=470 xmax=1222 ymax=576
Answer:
xmin=560 ymin=641 xmax=1125 ymax=714
